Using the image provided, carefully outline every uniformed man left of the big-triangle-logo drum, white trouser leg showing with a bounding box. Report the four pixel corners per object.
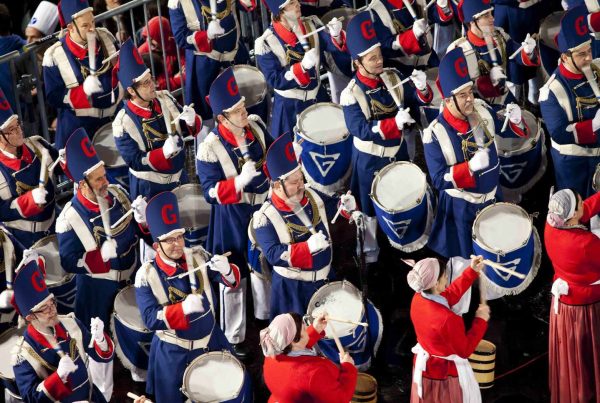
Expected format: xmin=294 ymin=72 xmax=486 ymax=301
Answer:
xmin=197 ymin=68 xmax=273 ymax=357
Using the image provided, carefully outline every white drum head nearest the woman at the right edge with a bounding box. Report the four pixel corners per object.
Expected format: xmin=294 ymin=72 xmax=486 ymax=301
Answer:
xmin=473 ymin=203 xmax=533 ymax=253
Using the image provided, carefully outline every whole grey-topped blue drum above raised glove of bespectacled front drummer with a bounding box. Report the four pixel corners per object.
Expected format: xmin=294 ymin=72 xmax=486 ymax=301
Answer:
xmin=173 ymin=183 xmax=211 ymax=247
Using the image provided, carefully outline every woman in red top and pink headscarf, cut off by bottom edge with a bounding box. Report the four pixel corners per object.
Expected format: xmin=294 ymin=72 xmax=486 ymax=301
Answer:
xmin=260 ymin=312 xmax=358 ymax=403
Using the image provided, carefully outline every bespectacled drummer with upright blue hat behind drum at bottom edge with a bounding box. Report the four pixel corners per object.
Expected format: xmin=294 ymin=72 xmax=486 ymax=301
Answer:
xmin=135 ymin=192 xmax=247 ymax=402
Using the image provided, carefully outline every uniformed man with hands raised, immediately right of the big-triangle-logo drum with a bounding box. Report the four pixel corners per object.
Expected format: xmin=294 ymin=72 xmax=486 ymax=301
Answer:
xmin=341 ymin=11 xmax=433 ymax=263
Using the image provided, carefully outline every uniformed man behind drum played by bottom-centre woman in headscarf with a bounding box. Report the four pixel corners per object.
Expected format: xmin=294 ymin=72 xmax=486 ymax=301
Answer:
xmin=253 ymin=134 xmax=356 ymax=318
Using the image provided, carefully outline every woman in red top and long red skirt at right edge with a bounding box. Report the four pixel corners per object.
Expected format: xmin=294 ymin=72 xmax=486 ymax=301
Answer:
xmin=544 ymin=189 xmax=600 ymax=403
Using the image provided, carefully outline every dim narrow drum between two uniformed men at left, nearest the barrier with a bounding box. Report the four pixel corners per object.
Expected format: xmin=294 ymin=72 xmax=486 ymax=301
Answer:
xmin=92 ymin=122 xmax=129 ymax=190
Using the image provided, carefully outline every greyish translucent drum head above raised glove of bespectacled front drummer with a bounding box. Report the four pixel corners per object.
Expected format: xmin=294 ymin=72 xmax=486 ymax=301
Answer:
xmin=173 ymin=184 xmax=211 ymax=228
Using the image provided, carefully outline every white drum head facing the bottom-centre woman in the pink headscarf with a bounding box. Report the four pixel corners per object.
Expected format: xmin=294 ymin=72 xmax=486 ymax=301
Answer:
xmin=308 ymin=281 xmax=364 ymax=338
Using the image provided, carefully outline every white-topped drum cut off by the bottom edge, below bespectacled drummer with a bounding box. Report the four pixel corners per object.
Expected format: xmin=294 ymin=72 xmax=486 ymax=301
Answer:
xmin=181 ymin=351 xmax=252 ymax=403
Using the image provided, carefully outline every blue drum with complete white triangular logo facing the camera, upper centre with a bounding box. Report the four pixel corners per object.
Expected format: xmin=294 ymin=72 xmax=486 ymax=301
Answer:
xmin=294 ymin=102 xmax=352 ymax=194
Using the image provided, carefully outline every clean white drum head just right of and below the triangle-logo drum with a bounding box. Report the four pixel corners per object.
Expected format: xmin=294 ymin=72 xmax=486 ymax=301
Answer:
xmin=371 ymin=161 xmax=427 ymax=212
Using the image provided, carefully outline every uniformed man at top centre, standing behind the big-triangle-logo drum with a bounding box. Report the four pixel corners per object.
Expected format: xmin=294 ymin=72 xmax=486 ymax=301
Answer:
xmin=254 ymin=0 xmax=347 ymax=136
